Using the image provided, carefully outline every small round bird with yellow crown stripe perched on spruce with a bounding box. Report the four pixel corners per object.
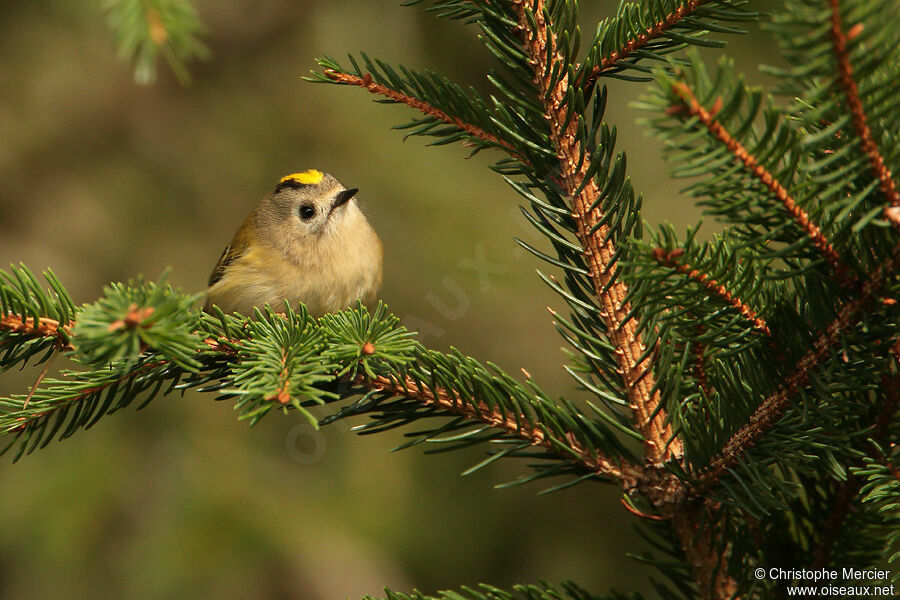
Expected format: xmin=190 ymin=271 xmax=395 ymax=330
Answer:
xmin=204 ymin=170 xmax=382 ymax=317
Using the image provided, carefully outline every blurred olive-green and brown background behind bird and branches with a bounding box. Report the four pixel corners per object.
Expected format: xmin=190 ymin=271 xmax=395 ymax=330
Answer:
xmin=0 ymin=0 xmax=775 ymax=599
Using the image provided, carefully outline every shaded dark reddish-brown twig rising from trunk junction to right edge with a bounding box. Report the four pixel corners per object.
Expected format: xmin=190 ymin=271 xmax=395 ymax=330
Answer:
xmin=693 ymin=243 xmax=900 ymax=494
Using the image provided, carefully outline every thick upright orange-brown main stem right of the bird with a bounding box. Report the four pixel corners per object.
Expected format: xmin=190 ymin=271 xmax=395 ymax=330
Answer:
xmin=514 ymin=0 xmax=682 ymax=463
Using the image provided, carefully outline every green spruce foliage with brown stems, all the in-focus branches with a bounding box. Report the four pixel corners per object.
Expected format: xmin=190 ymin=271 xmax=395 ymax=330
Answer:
xmin=0 ymin=0 xmax=900 ymax=600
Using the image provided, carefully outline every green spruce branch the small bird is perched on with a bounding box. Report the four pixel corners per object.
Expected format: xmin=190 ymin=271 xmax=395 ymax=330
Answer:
xmin=0 ymin=268 xmax=645 ymax=489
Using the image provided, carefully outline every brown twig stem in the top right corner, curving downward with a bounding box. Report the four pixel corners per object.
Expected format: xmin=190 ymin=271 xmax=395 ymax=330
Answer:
xmin=829 ymin=0 xmax=900 ymax=206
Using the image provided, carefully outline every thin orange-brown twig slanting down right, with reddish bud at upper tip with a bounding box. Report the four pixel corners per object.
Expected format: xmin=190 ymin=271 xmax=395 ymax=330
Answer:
xmin=672 ymin=82 xmax=849 ymax=278
